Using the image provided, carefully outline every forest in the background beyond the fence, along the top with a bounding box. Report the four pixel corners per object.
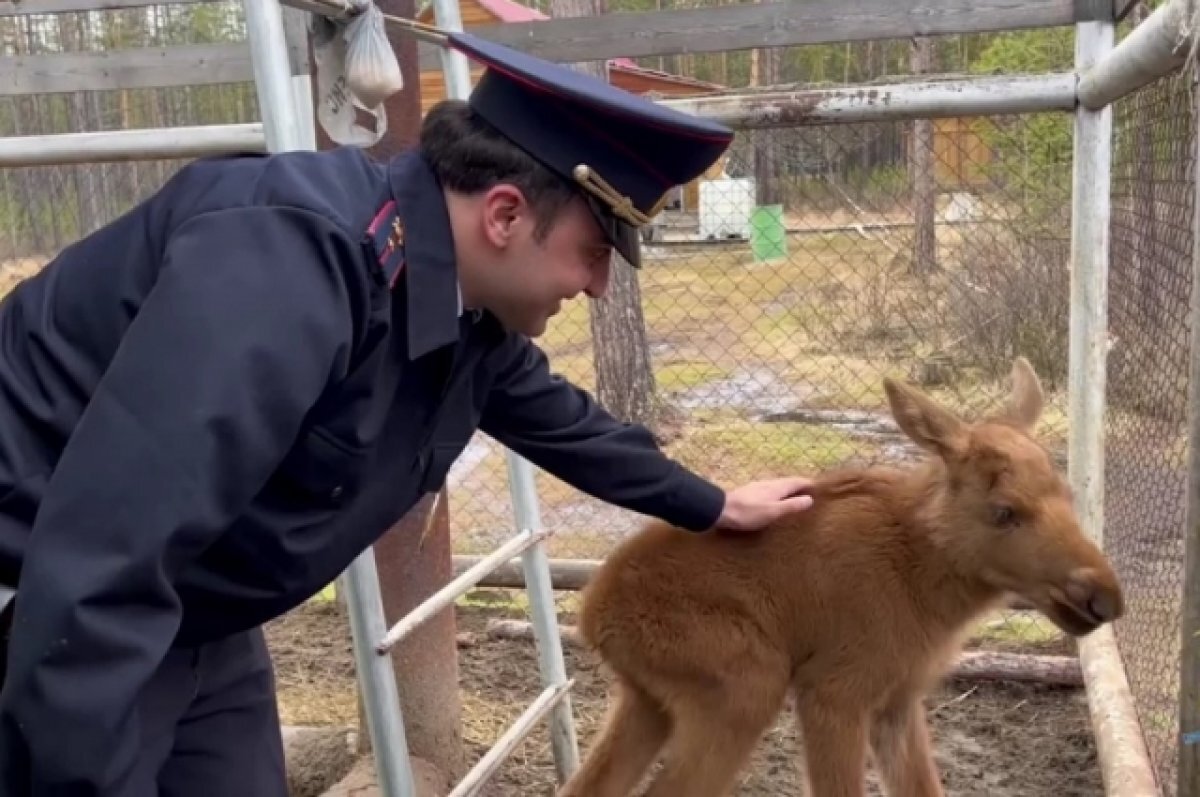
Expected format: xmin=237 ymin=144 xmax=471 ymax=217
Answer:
xmin=0 ymin=0 xmax=1089 ymax=259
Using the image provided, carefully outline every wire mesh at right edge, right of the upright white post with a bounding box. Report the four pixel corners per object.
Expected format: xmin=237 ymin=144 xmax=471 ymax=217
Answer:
xmin=1104 ymin=15 xmax=1196 ymax=797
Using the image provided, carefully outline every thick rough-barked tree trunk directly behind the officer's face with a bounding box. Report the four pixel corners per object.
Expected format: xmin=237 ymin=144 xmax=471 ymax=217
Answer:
xmin=550 ymin=0 xmax=659 ymax=429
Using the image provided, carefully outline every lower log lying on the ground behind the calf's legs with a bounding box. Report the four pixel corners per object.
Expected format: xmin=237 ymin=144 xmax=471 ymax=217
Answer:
xmin=486 ymin=619 xmax=1084 ymax=687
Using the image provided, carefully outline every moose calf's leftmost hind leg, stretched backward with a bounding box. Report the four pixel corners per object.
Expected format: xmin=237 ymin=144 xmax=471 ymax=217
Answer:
xmin=558 ymin=677 xmax=671 ymax=797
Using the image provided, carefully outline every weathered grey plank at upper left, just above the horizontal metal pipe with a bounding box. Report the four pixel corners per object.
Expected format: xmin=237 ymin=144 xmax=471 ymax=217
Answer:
xmin=0 ymin=43 xmax=254 ymax=96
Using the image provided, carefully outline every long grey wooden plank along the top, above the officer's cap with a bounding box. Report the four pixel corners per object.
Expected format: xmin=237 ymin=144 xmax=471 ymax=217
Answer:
xmin=420 ymin=0 xmax=1075 ymax=70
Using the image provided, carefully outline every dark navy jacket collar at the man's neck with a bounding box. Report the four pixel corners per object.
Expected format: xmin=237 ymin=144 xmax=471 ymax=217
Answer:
xmin=388 ymin=151 xmax=462 ymax=359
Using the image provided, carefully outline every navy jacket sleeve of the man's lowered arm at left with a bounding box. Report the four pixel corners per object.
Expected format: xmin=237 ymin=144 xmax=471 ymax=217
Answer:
xmin=0 ymin=208 xmax=366 ymax=797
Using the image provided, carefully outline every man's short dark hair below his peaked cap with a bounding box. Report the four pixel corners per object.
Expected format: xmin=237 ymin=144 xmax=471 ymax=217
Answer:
xmin=420 ymin=100 xmax=578 ymax=239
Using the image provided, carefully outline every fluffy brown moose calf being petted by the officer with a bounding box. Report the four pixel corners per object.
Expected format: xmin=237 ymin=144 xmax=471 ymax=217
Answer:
xmin=559 ymin=359 xmax=1123 ymax=797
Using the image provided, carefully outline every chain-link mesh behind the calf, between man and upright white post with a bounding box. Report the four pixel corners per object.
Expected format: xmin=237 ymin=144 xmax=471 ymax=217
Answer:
xmin=450 ymin=105 xmax=1072 ymax=649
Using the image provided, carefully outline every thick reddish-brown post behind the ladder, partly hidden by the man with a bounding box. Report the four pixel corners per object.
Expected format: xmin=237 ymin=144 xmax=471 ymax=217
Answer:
xmin=304 ymin=0 xmax=466 ymax=781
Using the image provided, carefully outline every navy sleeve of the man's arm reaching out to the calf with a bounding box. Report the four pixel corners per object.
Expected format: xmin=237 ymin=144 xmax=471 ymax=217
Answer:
xmin=480 ymin=335 xmax=725 ymax=532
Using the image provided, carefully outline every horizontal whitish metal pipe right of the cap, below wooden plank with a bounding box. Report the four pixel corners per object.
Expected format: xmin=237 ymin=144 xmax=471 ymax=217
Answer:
xmin=660 ymin=72 xmax=1075 ymax=130
